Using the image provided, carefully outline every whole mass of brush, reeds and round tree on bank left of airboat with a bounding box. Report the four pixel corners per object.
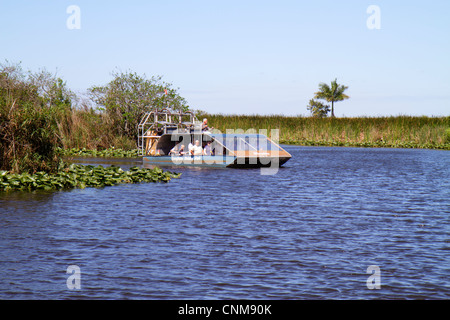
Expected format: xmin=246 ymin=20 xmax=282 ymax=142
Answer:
xmin=0 ymin=62 xmax=188 ymax=173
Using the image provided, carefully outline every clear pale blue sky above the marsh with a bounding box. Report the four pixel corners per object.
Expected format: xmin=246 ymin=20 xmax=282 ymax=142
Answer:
xmin=0 ymin=0 xmax=450 ymax=117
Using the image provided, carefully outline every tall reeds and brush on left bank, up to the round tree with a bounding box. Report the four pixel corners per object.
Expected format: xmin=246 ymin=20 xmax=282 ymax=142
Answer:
xmin=0 ymin=64 xmax=136 ymax=173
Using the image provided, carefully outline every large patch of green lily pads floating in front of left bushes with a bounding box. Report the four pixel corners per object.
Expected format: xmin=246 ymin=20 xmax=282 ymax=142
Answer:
xmin=0 ymin=164 xmax=180 ymax=191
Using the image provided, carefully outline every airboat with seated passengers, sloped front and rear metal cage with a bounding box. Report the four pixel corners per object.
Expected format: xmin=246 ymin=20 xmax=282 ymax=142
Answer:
xmin=138 ymin=110 xmax=291 ymax=168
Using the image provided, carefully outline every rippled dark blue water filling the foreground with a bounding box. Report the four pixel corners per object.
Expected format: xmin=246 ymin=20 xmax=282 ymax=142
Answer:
xmin=0 ymin=146 xmax=450 ymax=299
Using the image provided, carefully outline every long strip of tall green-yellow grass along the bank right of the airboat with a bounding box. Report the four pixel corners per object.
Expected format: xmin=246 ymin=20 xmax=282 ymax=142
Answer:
xmin=205 ymin=114 xmax=450 ymax=150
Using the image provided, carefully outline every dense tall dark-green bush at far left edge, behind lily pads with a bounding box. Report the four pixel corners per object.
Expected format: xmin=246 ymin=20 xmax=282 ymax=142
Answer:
xmin=0 ymin=61 xmax=71 ymax=172
